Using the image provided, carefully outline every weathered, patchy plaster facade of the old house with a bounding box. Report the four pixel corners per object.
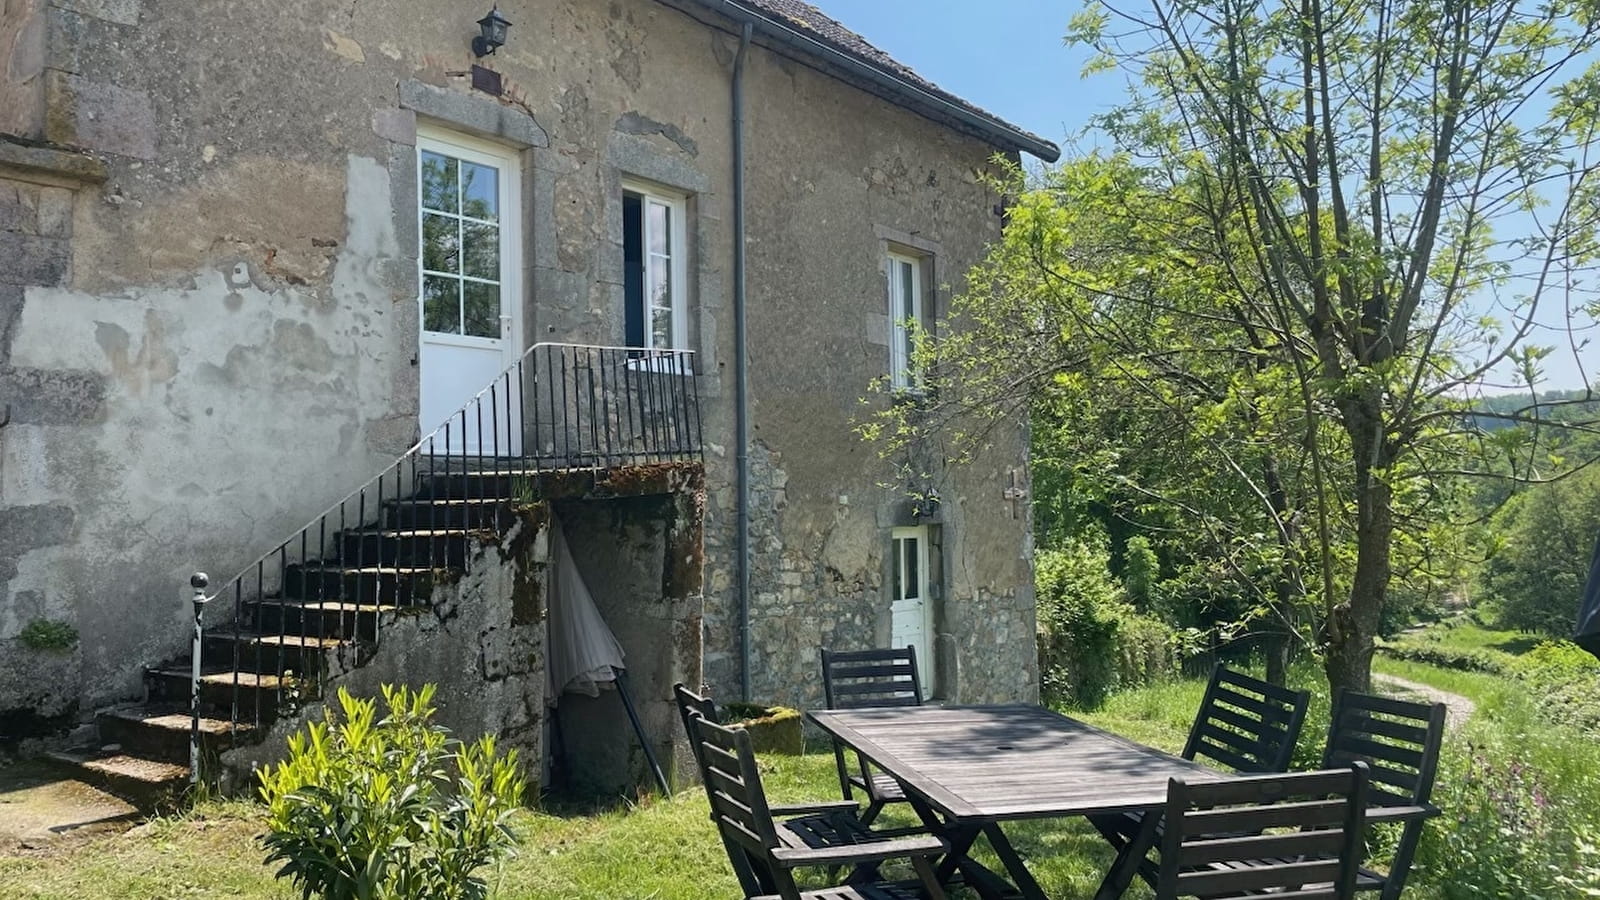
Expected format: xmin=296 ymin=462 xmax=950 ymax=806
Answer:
xmin=0 ymin=0 xmax=1037 ymax=723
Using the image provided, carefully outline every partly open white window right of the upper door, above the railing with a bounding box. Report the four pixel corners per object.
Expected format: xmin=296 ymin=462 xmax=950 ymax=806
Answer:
xmin=622 ymin=183 xmax=688 ymax=351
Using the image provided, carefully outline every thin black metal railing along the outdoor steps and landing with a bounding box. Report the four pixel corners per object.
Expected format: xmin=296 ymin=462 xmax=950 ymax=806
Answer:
xmin=190 ymin=343 xmax=702 ymax=777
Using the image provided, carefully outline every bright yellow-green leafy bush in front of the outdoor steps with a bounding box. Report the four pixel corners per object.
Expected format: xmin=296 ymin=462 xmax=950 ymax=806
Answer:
xmin=259 ymin=684 xmax=525 ymax=900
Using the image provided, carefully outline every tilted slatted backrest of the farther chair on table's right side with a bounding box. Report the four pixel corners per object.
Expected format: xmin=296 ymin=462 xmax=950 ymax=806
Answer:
xmin=1182 ymin=665 xmax=1310 ymax=773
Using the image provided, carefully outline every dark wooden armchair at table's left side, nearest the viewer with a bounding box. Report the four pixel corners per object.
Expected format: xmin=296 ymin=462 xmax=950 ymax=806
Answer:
xmin=686 ymin=713 xmax=949 ymax=900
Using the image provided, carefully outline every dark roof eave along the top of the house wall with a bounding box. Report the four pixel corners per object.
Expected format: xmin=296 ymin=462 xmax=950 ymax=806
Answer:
xmin=669 ymin=0 xmax=1061 ymax=162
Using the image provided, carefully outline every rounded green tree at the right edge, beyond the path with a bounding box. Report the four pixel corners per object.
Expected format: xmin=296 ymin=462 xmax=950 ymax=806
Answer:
xmin=1483 ymin=466 xmax=1600 ymax=637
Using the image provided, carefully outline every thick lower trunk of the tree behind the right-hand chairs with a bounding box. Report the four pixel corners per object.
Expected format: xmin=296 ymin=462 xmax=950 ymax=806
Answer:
xmin=1323 ymin=392 xmax=1394 ymax=692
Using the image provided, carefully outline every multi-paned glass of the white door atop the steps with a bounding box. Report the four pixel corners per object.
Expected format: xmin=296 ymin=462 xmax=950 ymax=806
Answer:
xmin=419 ymin=151 xmax=502 ymax=338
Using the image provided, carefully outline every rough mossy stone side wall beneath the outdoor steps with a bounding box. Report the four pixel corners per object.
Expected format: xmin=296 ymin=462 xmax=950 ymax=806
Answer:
xmin=222 ymin=504 xmax=550 ymax=794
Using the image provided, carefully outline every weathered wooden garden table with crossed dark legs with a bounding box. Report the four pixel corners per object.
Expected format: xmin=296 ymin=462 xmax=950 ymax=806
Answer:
xmin=810 ymin=706 xmax=1230 ymax=900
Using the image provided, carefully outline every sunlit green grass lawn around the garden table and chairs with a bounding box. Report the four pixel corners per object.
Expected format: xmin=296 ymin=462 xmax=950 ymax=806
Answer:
xmin=9 ymin=643 xmax=1600 ymax=900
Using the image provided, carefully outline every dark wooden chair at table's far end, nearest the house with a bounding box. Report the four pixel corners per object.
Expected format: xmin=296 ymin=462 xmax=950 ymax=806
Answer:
xmin=822 ymin=647 xmax=922 ymax=825
